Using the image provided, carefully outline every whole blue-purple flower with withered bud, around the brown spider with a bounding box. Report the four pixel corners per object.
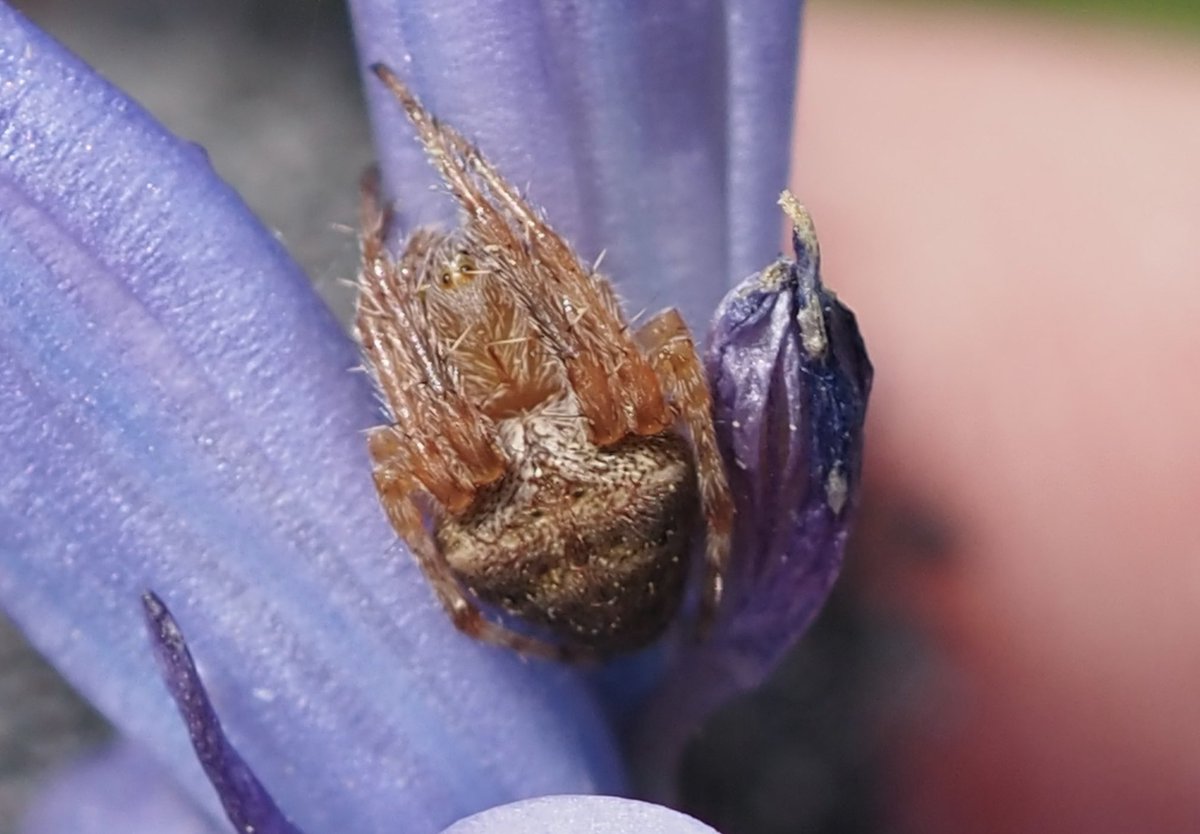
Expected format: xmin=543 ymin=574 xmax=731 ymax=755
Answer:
xmin=0 ymin=0 xmax=870 ymax=834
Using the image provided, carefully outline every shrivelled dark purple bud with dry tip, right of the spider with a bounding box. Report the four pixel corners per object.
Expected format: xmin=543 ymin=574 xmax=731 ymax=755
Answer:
xmin=634 ymin=194 xmax=872 ymax=799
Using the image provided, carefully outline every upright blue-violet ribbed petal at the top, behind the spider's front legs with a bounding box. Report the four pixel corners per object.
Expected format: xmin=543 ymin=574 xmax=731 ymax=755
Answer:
xmin=350 ymin=0 xmax=799 ymax=330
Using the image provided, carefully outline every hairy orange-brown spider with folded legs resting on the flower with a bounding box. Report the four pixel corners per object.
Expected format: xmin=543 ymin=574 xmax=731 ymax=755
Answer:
xmin=356 ymin=65 xmax=733 ymax=660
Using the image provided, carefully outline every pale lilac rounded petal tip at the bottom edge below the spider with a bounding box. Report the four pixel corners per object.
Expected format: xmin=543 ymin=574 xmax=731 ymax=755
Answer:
xmin=445 ymin=796 xmax=715 ymax=834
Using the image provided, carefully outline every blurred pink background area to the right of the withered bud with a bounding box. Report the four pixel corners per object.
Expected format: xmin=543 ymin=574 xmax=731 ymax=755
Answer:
xmin=793 ymin=0 xmax=1200 ymax=834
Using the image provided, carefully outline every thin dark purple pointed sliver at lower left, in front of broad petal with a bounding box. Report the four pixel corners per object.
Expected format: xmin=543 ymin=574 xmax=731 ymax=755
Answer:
xmin=142 ymin=593 xmax=299 ymax=834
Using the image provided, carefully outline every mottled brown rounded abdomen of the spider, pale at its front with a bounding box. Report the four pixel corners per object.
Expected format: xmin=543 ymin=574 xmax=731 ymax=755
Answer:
xmin=437 ymin=404 xmax=700 ymax=654
